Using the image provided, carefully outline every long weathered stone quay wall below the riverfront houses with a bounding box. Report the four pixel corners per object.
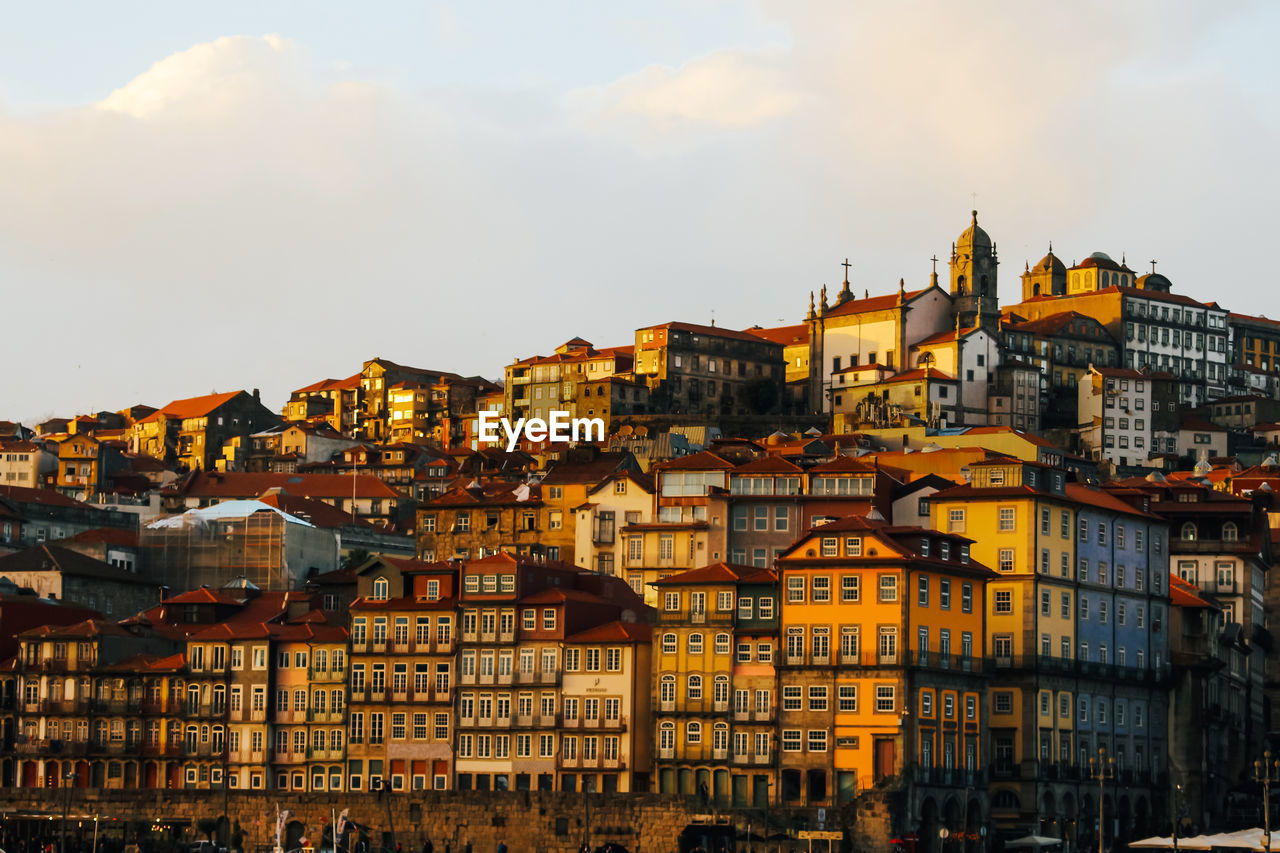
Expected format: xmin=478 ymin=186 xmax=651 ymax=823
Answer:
xmin=0 ymin=788 xmax=705 ymax=853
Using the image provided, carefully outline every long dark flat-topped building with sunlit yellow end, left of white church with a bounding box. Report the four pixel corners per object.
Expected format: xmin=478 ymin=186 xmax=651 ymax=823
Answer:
xmin=635 ymin=323 xmax=786 ymax=415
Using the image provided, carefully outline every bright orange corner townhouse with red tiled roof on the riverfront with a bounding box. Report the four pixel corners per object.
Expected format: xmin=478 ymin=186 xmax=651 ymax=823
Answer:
xmin=777 ymin=514 xmax=995 ymax=836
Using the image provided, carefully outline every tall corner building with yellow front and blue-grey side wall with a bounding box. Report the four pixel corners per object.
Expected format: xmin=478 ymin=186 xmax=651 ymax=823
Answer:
xmin=929 ymin=460 xmax=1167 ymax=839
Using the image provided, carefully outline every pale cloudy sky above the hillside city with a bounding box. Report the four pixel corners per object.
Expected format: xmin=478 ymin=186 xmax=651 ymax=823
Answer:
xmin=0 ymin=0 xmax=1280 ymax=423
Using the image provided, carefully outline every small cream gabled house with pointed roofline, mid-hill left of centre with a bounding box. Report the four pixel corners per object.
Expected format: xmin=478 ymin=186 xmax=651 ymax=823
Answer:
xmin=573 ymin=470 xmax=654 ymax=581
